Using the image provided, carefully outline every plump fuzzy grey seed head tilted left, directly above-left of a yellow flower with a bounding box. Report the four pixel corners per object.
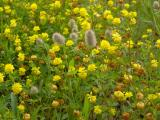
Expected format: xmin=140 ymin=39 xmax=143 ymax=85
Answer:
xmin=52 ymin=32 xmax=65 ymax=45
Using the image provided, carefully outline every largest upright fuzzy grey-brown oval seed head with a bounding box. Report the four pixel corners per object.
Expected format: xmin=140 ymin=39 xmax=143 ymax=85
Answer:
xmin=85 ymin=30 xmax=97 ymax=47
